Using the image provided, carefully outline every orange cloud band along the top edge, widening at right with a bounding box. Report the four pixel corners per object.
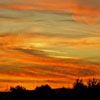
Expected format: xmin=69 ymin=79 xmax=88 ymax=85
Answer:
xmin=0 ymin=0 xmax=100 ymax=23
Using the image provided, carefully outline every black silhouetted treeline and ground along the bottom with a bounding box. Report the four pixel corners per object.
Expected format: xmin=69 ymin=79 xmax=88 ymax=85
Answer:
xmin=0 ymin=79 xmax=100 ymax=100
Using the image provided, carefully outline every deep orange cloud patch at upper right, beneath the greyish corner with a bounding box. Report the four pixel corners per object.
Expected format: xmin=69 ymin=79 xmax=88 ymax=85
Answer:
xmin=70 ymin=5 xmax=100 ymax=24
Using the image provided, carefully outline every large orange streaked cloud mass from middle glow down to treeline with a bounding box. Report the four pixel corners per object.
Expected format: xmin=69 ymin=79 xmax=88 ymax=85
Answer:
xmin=0 ymin=34 xmax=100 ymax=90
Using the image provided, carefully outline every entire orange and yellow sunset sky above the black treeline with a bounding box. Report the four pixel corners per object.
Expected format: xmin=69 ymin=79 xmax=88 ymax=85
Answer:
xmin=0 ymin=0 xmax=100 ymax=91
